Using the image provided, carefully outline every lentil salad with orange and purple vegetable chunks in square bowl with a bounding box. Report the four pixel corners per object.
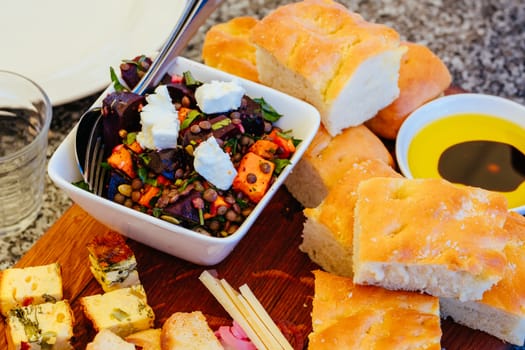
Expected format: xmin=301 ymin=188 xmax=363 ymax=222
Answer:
xmin=75 ymin=56 xmax=300 ymax=237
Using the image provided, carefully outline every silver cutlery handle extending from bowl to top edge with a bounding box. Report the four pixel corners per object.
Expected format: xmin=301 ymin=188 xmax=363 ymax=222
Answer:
xmin=133 ymin=0 xmax=222 ymax=95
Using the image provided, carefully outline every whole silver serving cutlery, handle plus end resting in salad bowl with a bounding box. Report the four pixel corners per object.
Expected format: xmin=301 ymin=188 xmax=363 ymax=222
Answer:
xmin=75 ymin=0 xmax=222 ymax=194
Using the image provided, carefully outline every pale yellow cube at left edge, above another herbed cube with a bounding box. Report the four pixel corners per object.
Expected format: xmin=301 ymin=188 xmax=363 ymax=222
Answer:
xmin=0 ymin=263 xmax=63 ymax=316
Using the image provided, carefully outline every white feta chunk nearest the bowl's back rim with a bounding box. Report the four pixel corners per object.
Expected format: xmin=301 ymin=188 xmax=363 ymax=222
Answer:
xmin=195 ymin=80 xmax=245 ymax=114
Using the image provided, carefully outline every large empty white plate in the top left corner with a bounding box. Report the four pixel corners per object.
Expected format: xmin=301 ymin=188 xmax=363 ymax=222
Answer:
xmin=0 ymin=0 xmax=185 ymax=105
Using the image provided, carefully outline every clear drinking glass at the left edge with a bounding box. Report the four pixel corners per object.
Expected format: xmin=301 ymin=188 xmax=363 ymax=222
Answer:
xmin=0 ymin=70 xmax=52 ymax=235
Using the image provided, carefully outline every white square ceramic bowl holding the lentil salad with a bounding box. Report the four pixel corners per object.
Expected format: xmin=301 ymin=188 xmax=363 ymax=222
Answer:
xmin=48 ymin=57 xmax=320 ymax=266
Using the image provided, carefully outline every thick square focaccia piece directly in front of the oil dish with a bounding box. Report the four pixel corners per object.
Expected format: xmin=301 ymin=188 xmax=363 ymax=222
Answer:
xmin=353 ymin=177 xmax=508 ymax=301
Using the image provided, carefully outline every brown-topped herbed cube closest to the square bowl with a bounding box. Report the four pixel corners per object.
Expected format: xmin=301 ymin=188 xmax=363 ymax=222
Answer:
xmin=87 ymin=231 xmax=140 ymax=292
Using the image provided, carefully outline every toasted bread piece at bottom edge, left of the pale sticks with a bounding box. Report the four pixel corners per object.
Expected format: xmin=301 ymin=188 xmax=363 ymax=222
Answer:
xmin=160 ymin=311 xmax=223 ymax=350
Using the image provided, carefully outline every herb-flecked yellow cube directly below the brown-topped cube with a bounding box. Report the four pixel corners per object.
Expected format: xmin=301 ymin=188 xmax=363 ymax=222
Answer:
xmin=80 ymin=285 xmax=155 ymax=337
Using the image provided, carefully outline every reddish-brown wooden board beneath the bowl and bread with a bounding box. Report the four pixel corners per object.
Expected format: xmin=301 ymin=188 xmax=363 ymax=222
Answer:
xmin=0 ymin=188 xmax=511 ymax=350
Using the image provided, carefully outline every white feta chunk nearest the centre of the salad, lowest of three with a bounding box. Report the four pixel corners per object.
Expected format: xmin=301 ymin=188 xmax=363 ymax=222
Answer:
xmin=193 ymin=136 xmax=237 ymax=190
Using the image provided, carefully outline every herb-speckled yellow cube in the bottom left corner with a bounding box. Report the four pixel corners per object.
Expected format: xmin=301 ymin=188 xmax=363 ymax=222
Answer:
xmin=6 ymin=300 xmax=74 ymax=350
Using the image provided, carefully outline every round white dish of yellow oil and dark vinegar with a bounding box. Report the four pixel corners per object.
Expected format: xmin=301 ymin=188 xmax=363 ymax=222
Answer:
xmin=395 ymin=94 xmax=525 ymax=214
